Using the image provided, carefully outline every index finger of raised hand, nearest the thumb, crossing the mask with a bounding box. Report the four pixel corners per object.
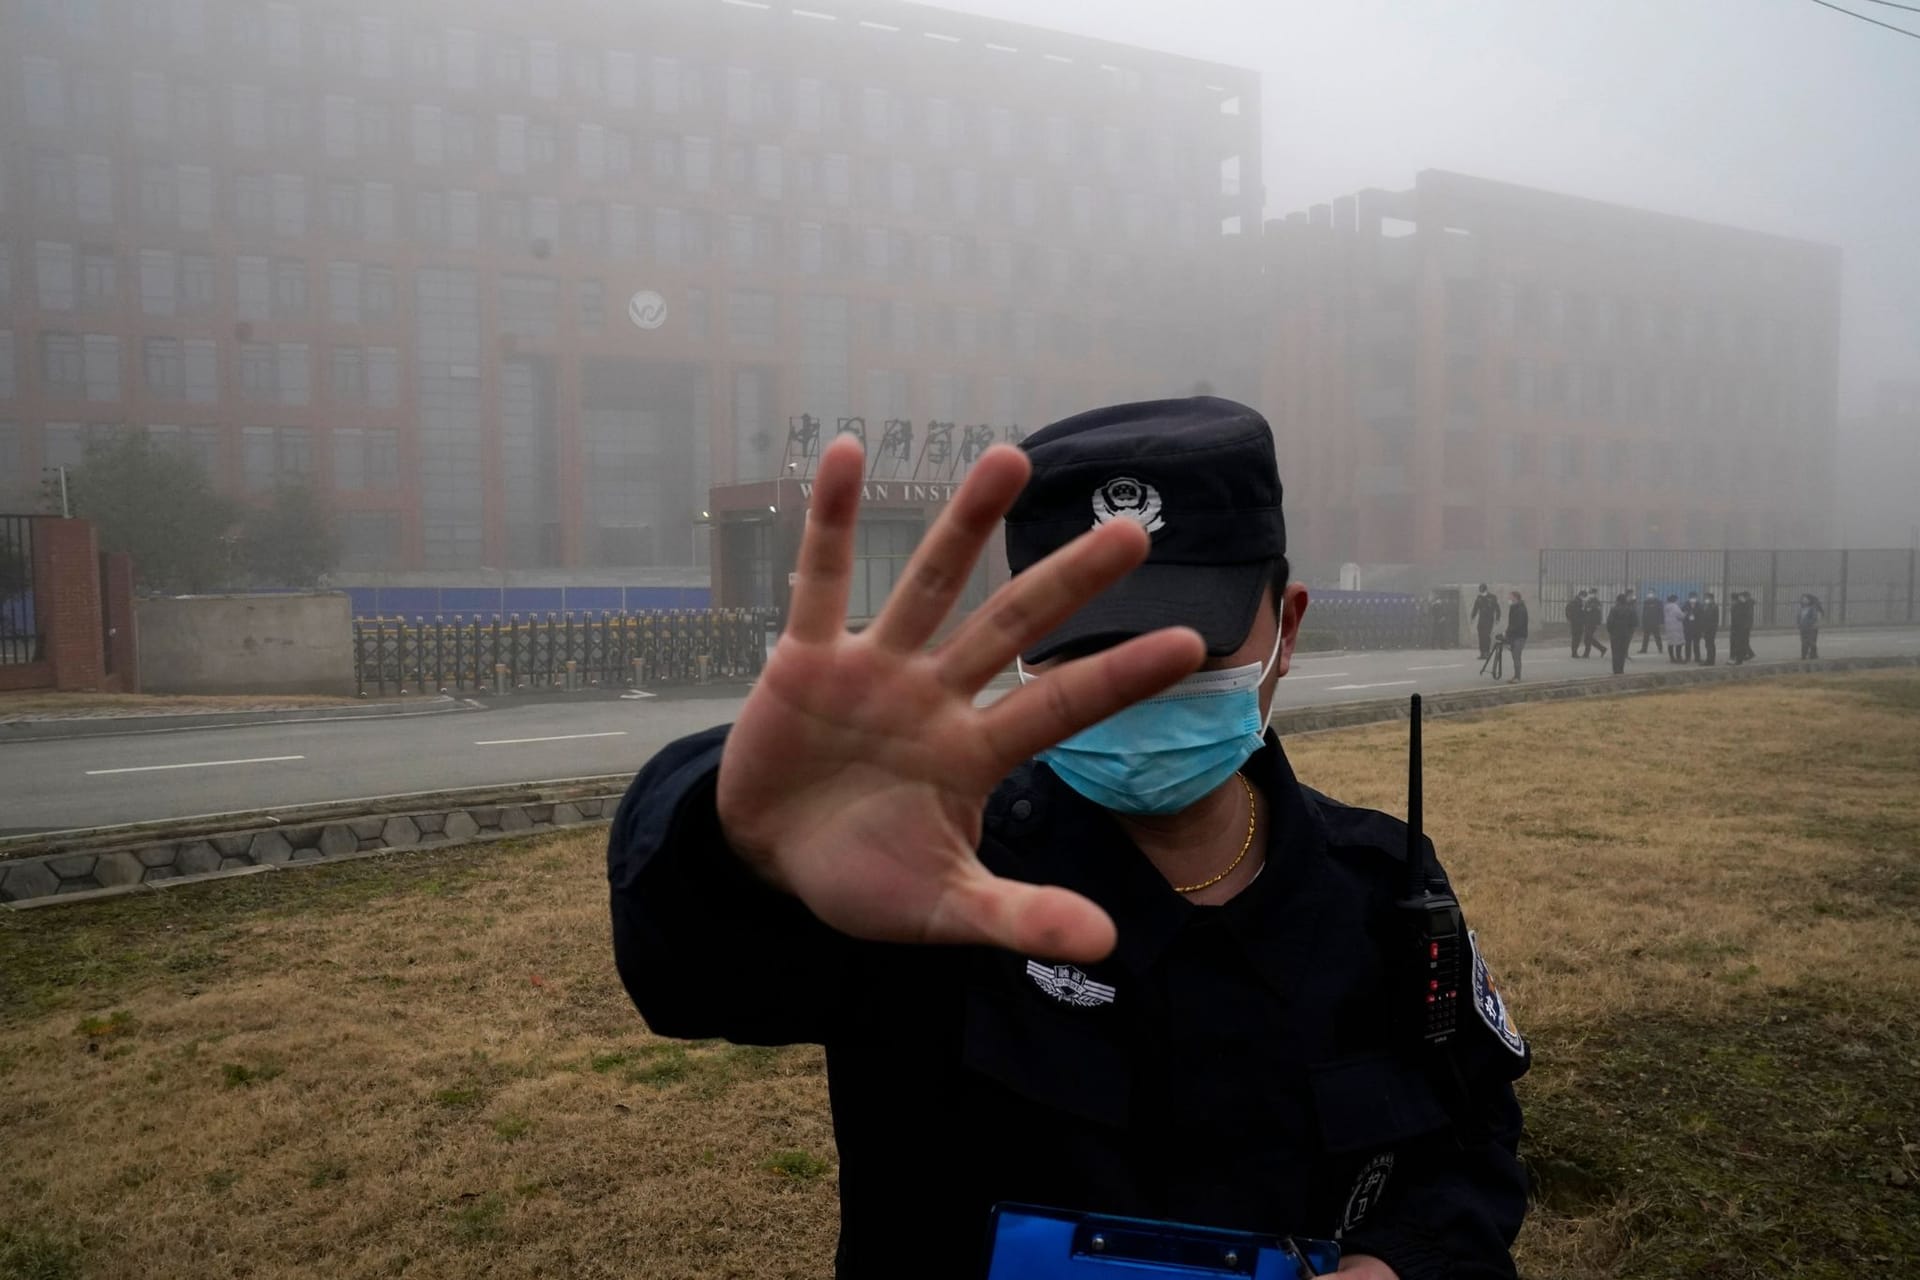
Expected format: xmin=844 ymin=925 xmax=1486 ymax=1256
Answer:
xmin=979 ymin=628 xmax=1206 ymax=773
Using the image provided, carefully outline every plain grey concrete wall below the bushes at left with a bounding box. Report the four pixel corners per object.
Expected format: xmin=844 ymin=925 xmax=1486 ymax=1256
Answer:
xmin=134 ymin=591 xmax=353 ymax=697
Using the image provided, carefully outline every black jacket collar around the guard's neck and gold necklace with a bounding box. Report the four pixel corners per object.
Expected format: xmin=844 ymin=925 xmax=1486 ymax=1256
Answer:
xmin=989 ymin=731 xmax=1327 ymax=994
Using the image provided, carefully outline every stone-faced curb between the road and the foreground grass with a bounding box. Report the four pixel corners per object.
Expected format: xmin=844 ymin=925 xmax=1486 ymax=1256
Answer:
xmin=0 ymin=656 xmax=1920 ymax=910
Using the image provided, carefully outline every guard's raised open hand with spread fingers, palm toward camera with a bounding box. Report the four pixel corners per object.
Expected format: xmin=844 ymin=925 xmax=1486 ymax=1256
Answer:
xmin=718 ymin=436 xmax=1206 ymax=961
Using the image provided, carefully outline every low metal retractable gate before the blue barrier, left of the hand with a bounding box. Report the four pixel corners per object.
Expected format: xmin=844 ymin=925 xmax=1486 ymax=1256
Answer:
xmin=353 ymin=608 xmax=774 ymax=697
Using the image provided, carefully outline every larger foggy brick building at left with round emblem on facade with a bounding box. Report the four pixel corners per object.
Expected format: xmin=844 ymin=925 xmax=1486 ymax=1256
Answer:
xmin=0 ymin=0 xmax=1261 ymax=580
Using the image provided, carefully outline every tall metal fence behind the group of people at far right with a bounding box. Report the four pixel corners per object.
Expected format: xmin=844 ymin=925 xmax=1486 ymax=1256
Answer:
xmin=1534 ymin=549 xmax=1920 ymax=628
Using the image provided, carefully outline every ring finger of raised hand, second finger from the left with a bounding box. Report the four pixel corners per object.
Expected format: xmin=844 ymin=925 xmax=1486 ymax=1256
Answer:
xmin=868 ymin=445 xmax=1033 ymax=652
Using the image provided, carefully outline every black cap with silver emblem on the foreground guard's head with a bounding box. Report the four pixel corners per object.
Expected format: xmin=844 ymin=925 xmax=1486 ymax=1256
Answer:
xmin=1006 ymin=395 xmax=1286 ymax=662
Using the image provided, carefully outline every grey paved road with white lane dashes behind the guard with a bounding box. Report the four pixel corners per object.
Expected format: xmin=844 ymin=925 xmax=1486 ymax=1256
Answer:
xmin=0 ymin=629 xmax=1920 ymax=835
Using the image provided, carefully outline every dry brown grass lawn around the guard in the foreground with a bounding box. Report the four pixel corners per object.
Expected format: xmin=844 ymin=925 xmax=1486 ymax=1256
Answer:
xmin=0 ymin=674 xmax=1920 ymax=1280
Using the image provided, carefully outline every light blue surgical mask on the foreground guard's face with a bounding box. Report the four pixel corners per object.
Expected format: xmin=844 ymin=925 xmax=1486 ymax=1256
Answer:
xmin=1020 ymin=629 xmax=1281 ymax=814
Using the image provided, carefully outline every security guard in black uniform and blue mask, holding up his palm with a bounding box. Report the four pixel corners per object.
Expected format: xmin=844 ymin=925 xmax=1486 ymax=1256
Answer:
xmin=609 ymin=397 xmax=1528 ymax=1280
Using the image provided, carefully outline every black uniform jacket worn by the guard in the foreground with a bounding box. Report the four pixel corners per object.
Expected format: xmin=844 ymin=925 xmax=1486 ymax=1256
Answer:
xmin=607 ymin=727 xmax=1528 ymax=1280
